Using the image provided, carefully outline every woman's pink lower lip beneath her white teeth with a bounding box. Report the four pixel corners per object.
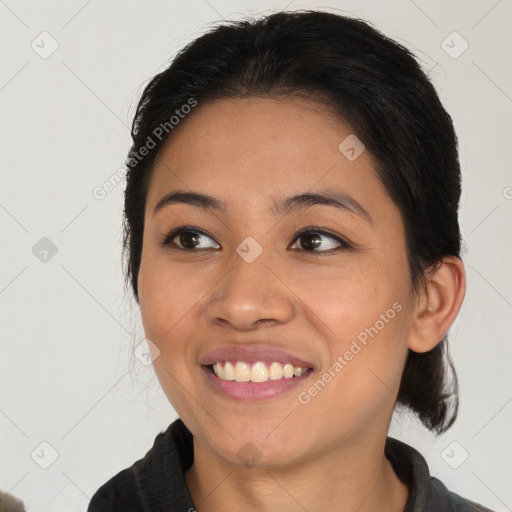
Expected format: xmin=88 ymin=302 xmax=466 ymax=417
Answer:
xmin=202 ymin=366 xmax=313 ymax=402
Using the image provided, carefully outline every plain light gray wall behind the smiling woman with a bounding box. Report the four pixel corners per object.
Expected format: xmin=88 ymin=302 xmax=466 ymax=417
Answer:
xmin=0 ymin=0 xmax=512 ymax=512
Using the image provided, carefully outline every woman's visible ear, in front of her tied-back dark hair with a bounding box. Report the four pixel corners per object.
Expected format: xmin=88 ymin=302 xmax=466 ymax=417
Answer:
xmin=407 ymin=256 xmax=466 ymax=353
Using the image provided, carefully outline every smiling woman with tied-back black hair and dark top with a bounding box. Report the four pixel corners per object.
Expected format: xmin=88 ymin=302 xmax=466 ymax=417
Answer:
xmin=89 ymin=11 xmax=488 ymax=512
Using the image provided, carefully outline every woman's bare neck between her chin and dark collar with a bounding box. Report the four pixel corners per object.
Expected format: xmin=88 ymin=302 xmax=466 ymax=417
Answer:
xmin=185 ymin=437 xmax=409 ymax=512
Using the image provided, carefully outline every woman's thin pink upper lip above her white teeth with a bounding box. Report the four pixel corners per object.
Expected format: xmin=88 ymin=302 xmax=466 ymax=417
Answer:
xmin=199 ymin=344 xmax=314 ymax=368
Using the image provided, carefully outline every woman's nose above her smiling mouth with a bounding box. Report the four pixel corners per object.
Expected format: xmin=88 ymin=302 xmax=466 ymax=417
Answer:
xmin=206 ymin=251 xmax=295 ymax=331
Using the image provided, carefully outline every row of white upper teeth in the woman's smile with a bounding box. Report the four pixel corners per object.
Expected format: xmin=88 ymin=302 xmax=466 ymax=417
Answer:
xmin=213 ymin=361 xmax=307 ymax=382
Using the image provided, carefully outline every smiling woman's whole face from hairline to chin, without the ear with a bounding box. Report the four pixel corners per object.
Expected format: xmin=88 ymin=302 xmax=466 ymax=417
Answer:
xmin=138 ymin=99 xmax=412 ymax=465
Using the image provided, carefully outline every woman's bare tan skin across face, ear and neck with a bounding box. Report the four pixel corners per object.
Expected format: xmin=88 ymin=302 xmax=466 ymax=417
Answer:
xmin=138 ymin=98 xmax=465 ymax=512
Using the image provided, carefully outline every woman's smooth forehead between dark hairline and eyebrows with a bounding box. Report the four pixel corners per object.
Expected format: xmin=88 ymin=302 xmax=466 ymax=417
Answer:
xmin=147 ymin=98 xmax=387 ymax=216
